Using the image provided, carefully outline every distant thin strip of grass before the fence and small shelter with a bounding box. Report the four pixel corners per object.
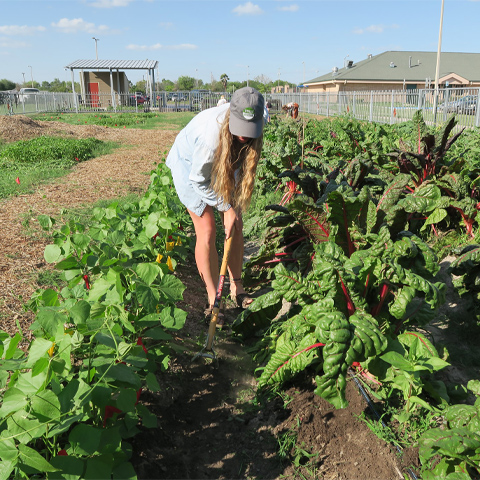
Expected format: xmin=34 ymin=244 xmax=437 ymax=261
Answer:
xmin=31 ymin=112 xmax=195 ymax=130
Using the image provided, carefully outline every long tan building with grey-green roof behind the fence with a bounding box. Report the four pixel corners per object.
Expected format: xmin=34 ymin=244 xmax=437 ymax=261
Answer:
xmin=304 ymin=51 xmax=480 ymax=93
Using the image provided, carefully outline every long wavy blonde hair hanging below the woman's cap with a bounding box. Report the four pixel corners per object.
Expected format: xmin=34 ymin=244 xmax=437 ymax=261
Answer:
xmin=210 ymin=111 xmax=263 ymax=212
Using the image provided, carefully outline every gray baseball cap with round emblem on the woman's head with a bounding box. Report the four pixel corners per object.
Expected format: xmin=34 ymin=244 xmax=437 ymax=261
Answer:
xmin=230 ymin=87 xmax=265 ymax=138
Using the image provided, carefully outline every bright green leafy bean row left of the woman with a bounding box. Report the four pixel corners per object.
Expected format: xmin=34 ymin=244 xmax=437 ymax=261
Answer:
xmin=0 ymin=160 xmax=188 ymax=480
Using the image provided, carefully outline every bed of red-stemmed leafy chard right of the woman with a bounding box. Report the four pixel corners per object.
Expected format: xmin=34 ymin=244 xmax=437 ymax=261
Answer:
xmin=234 ymin=112 xmax=480 ymax=479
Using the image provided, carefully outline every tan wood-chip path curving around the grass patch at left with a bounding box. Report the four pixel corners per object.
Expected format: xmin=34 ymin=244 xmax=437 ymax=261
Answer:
xmin=0 ymin=116 xmax=177 ymax=340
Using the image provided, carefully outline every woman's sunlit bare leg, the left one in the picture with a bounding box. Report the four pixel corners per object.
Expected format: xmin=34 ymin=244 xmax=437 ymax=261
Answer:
xmin=188 ymin=205 xmax=219 ymax=305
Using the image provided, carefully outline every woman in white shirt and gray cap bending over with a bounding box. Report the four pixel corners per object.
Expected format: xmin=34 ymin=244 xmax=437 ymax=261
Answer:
xmin=166 ymin=87 xmax=265 ymax=315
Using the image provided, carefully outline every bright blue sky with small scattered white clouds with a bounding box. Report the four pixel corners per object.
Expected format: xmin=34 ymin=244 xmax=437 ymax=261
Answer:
xmin=0 ymin=0 xmax=480 ymax=85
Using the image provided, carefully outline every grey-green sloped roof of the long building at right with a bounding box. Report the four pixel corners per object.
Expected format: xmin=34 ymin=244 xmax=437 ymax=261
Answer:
xmin=304 ymin=51 xmax=480 ymax=87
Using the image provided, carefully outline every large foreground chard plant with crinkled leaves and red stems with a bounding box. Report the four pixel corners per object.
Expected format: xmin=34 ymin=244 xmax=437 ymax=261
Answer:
xmin=238 ymin=182 xmax=444 ymax=407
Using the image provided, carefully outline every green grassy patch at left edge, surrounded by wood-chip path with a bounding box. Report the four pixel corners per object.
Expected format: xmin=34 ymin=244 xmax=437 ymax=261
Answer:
xmin=0 ymin=137 xmax=117 ymax=198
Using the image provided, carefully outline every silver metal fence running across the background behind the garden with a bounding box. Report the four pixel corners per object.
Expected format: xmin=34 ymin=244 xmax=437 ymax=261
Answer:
xmin=0 ymin=88 xmax=480 ymax=128
